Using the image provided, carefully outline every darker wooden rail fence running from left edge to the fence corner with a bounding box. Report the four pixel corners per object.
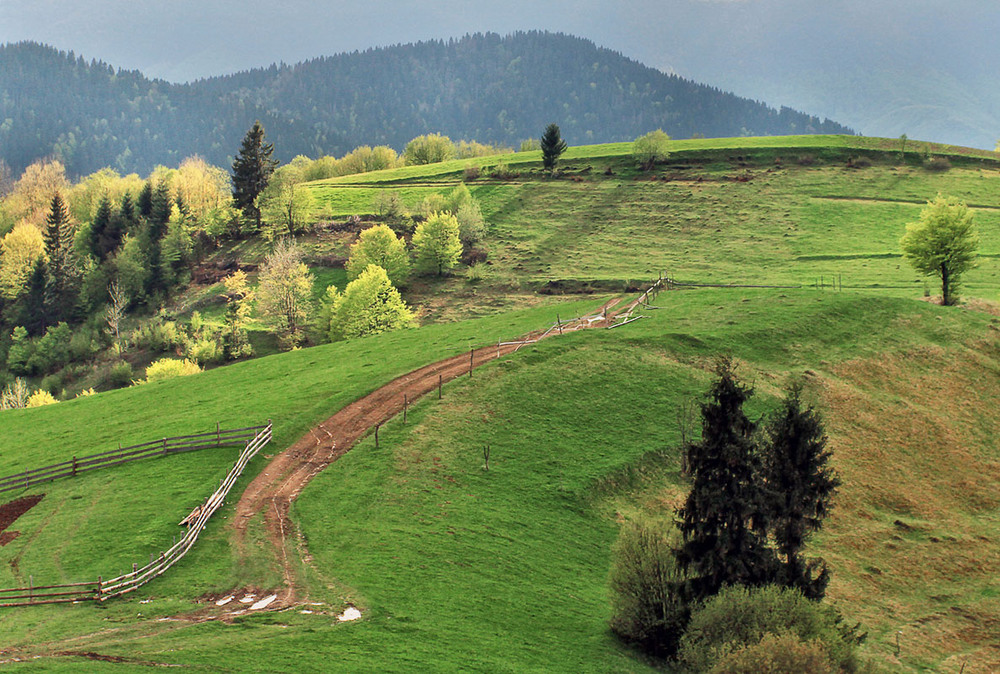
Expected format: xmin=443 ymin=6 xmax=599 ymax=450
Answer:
xmin=0 ymin=424 xmax=265 ymax=492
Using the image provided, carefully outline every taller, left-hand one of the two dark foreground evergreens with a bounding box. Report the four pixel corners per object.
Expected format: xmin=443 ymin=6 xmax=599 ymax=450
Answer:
xmin=677 ymin=359 xmax=777 ymax=601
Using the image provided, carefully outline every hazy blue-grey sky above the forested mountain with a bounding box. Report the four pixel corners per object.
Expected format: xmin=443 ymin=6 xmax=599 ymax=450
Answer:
xmin=0 ymin=0 xmax=1000 ymax=145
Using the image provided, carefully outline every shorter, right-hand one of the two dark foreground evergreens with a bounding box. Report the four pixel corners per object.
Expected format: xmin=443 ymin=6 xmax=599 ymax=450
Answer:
xmin=761 ymin=385 xmax=840 ymax=599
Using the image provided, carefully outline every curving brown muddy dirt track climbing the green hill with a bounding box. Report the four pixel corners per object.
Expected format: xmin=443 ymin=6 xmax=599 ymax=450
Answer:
xmin=233 ymin=300 xmax=635 ymax=606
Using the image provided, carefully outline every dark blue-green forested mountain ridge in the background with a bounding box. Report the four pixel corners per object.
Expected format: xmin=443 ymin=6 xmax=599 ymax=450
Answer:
xmin=0 ymin=32 xmax=852 ymax=174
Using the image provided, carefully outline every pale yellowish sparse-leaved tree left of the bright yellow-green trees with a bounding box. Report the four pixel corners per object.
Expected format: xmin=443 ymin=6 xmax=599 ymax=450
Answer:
xmin=256 ymin=239 xmax=313 ymax=347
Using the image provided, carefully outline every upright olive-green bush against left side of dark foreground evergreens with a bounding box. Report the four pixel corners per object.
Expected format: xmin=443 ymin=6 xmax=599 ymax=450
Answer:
xmin=610 ymin=522 xmax=687 ymax=656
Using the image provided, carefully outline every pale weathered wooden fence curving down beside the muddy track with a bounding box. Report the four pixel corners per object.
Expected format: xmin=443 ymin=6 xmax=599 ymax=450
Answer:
xmin=0 ymin=422 xmax=271 ymax=607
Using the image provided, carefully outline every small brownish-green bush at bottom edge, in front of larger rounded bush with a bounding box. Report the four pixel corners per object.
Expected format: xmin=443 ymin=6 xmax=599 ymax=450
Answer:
xmin=709 ymin=633 xmax=835 ymax=674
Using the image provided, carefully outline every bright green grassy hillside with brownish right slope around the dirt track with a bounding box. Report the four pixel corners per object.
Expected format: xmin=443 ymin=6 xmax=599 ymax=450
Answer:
xmin=0 ymin=137 xmax=1000 ymax=673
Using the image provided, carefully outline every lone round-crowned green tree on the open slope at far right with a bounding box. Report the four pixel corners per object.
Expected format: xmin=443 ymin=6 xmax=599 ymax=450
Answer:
xmin=899 ymin=194 xmax=979 ymax=306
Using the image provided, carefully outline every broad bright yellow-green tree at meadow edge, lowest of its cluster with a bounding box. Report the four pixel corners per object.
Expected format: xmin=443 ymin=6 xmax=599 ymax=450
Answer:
xmin=326 ymin=264 xmax=415 ymax=341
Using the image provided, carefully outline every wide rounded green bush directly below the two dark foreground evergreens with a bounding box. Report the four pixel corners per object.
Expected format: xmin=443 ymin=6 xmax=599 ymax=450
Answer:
xmin=678 ymin=585 xmax=863 ymax=672
